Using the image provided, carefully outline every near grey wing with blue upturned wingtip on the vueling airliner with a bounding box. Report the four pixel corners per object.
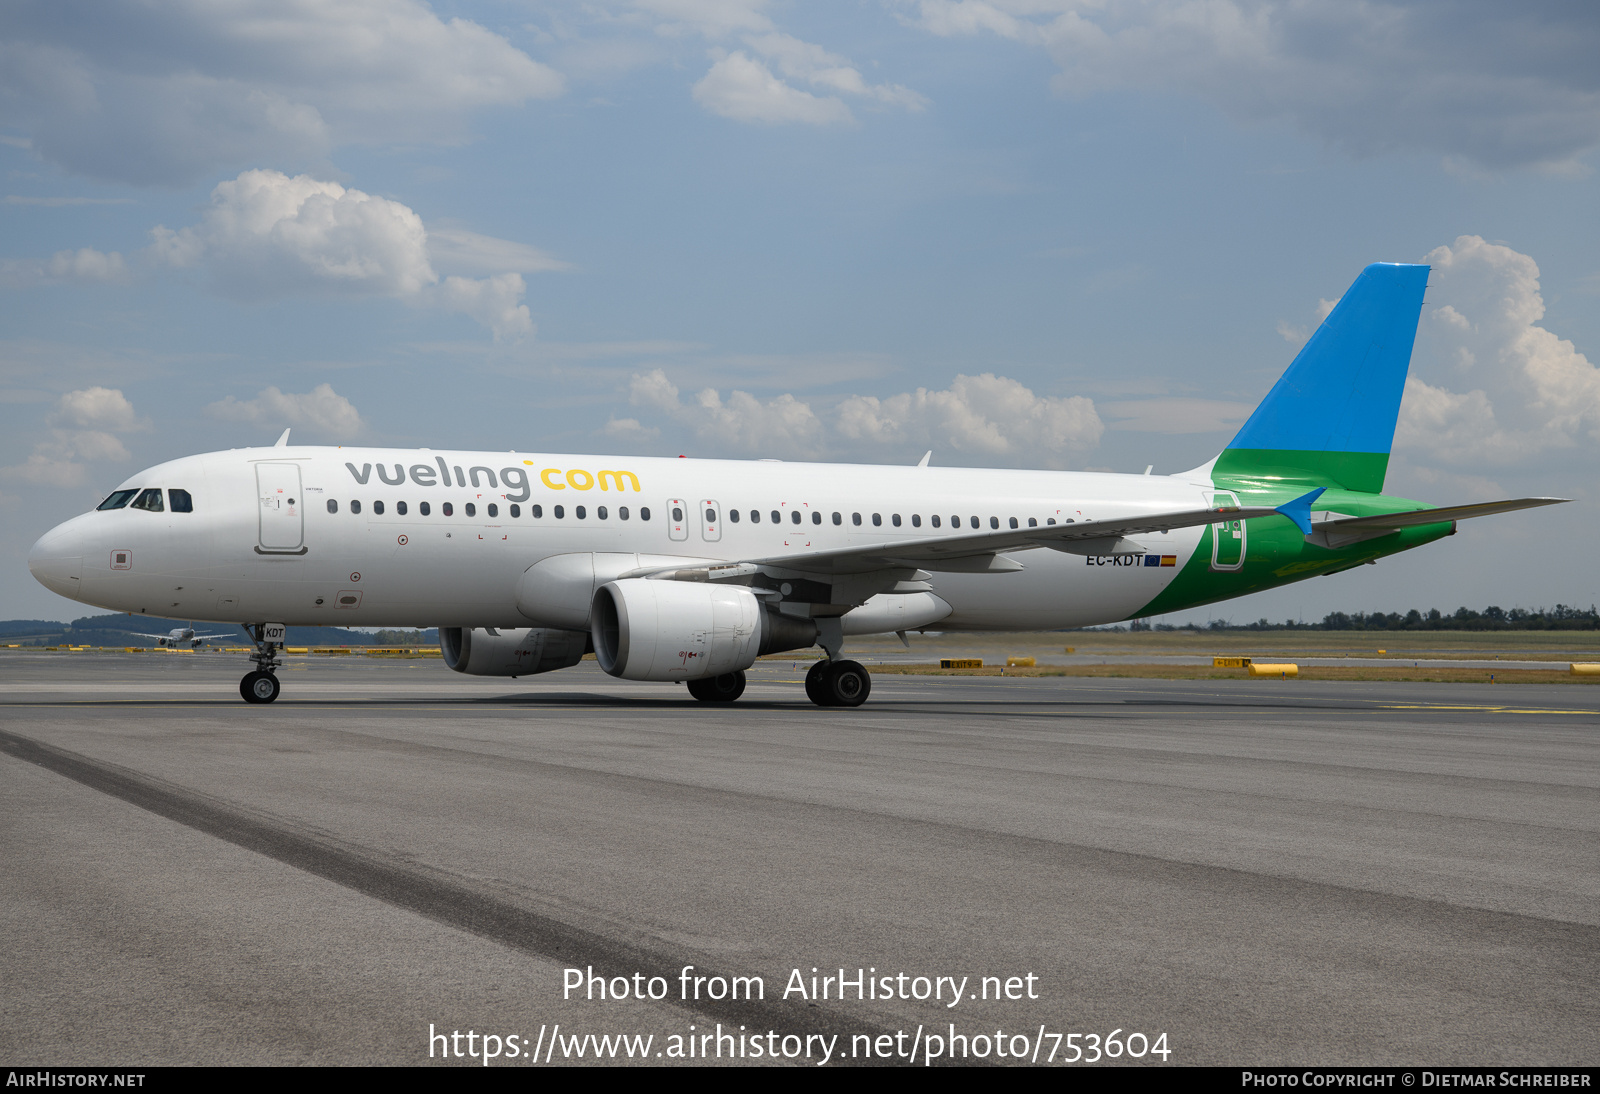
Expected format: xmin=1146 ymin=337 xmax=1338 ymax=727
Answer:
xmin=747 ymin=489 xmax=1292 ymax=574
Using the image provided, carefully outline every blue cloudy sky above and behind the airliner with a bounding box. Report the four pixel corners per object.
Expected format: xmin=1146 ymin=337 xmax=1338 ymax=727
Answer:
xmin=0 ymin=0 xmax=1600 ymax=621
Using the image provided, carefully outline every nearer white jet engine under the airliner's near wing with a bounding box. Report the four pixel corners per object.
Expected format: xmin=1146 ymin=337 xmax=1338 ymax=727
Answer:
xmin=590 ymin=577 xmax=816 ymax=680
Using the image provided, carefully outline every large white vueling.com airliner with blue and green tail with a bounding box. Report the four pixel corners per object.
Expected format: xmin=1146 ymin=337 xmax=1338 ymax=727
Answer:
xmin=29 ymin=262 xmax=1565 ymax=707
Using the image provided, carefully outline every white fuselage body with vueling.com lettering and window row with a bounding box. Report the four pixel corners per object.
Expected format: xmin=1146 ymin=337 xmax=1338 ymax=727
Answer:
xmin=30 ymin=448 xmax=1211 ymax=630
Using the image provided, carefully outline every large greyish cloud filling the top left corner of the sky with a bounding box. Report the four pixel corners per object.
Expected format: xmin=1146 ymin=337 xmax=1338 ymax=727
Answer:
xmin=0 ymin=0 xmax=563 ymax=184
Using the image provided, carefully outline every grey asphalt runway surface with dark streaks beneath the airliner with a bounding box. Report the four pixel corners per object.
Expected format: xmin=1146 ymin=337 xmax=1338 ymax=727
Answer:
xmin=0 ymin=651 xmax=1600 ymax=1067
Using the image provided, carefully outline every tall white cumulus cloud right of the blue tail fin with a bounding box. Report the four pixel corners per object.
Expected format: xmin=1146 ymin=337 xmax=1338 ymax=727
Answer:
xmin=1395 ymin=235 xmax=1600 ymax=467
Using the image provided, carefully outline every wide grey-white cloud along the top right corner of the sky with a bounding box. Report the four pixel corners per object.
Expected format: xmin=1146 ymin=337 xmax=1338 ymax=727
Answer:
xmin=901 ymin=0 xmax=1600 ymax=168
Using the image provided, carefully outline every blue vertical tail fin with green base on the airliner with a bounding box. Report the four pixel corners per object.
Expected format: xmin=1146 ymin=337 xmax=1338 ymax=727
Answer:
xmin=1213 ymin=262 xmax=1427 ymax=494
